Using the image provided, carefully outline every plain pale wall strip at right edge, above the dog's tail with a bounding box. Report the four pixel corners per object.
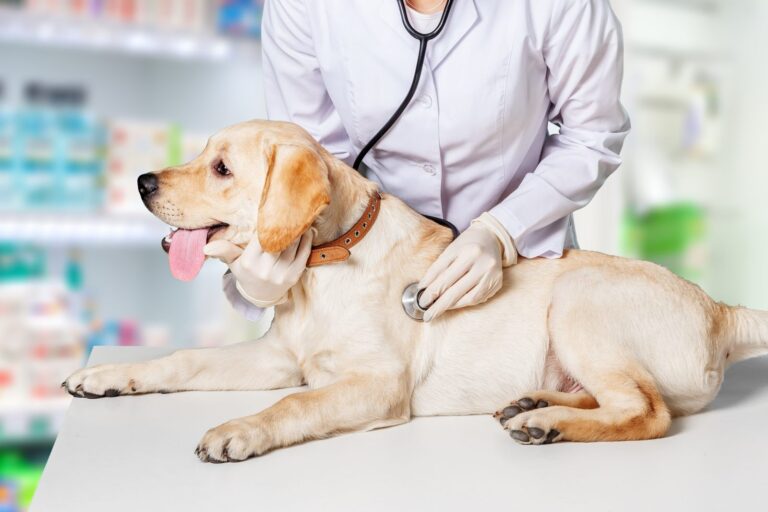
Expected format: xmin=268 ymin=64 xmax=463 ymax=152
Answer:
xmin=713 ymin=0 xmax=768 ymax=309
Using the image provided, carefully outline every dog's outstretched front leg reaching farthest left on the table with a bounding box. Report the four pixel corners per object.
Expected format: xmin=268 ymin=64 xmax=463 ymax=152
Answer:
xmin=63 ymin=335 xmax=302 ymax=398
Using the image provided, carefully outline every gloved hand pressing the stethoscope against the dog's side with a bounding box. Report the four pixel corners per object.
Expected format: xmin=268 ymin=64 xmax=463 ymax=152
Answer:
xmin=419 ymin=213 xmax=517 ymax=322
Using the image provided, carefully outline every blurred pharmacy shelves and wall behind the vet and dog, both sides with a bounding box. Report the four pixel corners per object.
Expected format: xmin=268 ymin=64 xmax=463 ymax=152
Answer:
xmin=0 ymin=0 xmax=768 ymax=512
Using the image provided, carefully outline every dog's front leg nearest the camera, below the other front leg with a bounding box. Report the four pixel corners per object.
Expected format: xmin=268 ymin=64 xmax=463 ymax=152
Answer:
xmin=195 ymin=375 xmax=410 ymax=462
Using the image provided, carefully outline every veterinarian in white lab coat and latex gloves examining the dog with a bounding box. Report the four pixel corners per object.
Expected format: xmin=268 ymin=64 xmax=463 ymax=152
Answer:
xmin=209 ymin=0 xmax=630 ymax=321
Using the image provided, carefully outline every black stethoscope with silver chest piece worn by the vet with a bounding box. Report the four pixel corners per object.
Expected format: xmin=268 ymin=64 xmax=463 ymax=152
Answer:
xmin=353 ymin=0 xmax=459 ymax=322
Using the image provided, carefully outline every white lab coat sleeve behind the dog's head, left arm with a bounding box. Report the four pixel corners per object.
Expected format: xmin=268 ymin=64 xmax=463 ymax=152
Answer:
xmin=261 ymin=0 xmax=353 ymax=164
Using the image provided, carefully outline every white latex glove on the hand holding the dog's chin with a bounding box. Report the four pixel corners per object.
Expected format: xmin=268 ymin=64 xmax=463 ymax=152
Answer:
xmin=203 ymin=229 xmax=314 ymax=308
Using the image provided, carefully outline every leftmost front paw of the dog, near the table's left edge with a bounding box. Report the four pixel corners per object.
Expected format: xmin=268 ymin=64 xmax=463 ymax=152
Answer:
xmin=62 ymin=364 xmax=139 ymax=398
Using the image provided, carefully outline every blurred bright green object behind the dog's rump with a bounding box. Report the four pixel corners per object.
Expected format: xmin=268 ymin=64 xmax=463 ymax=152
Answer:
xmin=624 ymin=203 xmax=707 ymax=282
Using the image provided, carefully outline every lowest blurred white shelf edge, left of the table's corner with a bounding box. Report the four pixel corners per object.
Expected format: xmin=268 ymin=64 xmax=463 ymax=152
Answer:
xmin=0 ymin=396 xmax=72 ymax=448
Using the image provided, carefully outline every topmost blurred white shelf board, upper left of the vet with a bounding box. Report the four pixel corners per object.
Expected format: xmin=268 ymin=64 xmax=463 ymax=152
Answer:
xmin=0 ymin=7 xmax=261 ymax=62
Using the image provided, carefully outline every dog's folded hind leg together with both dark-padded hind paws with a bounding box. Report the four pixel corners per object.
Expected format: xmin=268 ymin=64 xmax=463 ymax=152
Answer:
xmin=499 ymin=270 xmax=671 ymax=444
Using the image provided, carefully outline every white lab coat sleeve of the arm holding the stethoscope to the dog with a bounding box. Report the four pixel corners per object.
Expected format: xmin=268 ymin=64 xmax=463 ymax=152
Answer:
xmin=490 ymin=0 xmax=630 ymax=258
